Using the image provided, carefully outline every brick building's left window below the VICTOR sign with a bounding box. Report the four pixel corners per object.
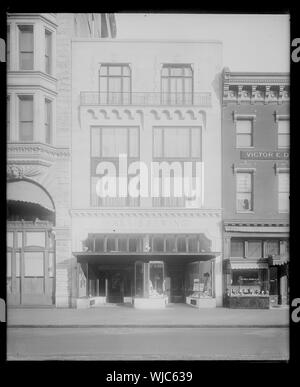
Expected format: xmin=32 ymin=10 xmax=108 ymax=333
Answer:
xmin=236 ymin=172 xmax=253 ymax=212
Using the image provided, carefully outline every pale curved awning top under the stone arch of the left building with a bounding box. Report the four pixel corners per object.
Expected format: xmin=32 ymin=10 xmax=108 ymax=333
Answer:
xmin=7 ymin=180 xmax=55 ymax=212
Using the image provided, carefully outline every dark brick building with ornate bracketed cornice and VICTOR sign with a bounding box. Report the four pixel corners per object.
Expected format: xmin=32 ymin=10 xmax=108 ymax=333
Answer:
xmin=222 ymin=69 xmax=289 ymax=307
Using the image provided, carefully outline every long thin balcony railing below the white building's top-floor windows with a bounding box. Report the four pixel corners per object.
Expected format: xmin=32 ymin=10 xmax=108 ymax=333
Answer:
xmin=80 ymin=91 xmax=211 ymax=107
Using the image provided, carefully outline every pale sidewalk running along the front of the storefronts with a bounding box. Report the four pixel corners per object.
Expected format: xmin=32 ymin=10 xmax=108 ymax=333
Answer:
xmin=7 ymin=304 xmax=289 ymax=328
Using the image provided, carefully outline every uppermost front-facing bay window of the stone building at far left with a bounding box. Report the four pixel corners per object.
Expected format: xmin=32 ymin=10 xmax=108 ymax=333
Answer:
xmin=19 ymin=25 xmax=33 ymax=70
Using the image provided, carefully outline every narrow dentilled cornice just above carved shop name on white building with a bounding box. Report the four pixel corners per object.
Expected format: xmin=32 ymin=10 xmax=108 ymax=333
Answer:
xmin=70 ymin=208 xmax=222 ymax=218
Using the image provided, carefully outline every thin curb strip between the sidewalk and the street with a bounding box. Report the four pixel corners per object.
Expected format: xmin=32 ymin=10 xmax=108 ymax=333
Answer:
xmin=7 ymin=324 xmax=289 ymax=328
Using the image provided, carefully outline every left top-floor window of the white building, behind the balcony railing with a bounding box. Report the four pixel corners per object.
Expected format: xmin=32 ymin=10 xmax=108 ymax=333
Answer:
xmin=99 ymin=64 xmax=131 ymax=105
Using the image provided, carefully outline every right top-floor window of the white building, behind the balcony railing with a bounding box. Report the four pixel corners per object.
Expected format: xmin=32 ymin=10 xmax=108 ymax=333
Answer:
xmin=161 ymin=64 xmax=193 ymax=105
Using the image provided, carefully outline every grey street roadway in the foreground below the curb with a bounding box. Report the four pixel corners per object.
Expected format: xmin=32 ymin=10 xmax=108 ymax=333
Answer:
xmin=7 ymin=327 xmax=289 ymax=361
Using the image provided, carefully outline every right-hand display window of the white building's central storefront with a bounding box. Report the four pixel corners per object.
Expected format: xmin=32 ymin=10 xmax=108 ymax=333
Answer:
xmin=187 ymin=260 xmax=213 ymax=298
